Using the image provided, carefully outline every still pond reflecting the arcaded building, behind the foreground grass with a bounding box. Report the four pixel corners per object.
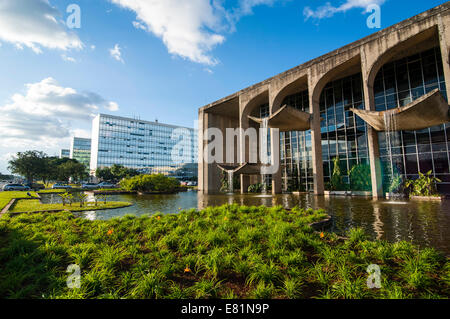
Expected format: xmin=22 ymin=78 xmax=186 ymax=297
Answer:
xmin=44 ymin=192 xmax=450 ymax=256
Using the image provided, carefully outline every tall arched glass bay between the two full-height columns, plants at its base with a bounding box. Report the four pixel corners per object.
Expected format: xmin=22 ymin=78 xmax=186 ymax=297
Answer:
xmin=320 ymin=73 xmax=369 ymax=188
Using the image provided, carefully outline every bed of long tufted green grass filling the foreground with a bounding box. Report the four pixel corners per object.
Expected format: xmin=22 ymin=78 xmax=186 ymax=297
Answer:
xmin=0 ymin=205 xmax=450 ymax=298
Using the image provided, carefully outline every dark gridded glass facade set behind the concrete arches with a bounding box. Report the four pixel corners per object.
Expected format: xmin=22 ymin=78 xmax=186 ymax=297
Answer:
xmin=251 ymin=47 xmax=450 ymax=193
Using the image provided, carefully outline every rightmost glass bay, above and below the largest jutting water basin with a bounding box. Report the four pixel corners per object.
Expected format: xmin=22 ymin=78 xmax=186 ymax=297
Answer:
xmin=374 ymin=47 xmax=450 ymax=193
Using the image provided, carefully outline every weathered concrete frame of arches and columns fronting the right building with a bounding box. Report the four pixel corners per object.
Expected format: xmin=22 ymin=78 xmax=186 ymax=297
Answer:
xmin=199 ymin=3 xmax=450 ymax=197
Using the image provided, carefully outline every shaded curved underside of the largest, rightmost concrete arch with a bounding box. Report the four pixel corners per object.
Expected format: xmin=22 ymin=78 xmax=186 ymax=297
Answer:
xmin=365 ymin=25 xmax=439 ymax=95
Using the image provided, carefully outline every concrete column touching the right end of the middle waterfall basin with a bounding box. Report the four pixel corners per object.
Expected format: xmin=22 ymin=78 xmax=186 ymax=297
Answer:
xmin=308 ymin=72 xmax=325 ymax=195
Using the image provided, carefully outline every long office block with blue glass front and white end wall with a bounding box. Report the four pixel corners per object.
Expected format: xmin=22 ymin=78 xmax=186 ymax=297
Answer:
xmin=90 ymin=114 xmax=198 ymax=179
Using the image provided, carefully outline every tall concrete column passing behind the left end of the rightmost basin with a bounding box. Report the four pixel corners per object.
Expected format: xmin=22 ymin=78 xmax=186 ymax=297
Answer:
xmin=361 ymin=47 xmax=384 ymax=198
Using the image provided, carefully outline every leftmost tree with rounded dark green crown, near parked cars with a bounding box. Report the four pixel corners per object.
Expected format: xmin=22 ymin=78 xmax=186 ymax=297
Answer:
xmin=8 ymin=151 xmax=47 ymax=183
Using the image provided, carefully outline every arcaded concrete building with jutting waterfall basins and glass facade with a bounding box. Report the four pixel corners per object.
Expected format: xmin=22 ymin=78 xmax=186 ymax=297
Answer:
xmin=199 ymin=3 xmax=450 ymax=198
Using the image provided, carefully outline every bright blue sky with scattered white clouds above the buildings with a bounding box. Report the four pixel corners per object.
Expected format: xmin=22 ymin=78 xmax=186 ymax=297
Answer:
xmin=0 ymin=0 xmax=446 ymax=173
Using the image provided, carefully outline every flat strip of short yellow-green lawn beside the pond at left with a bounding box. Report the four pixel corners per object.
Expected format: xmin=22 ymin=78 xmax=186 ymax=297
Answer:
xmin=9 ymin=199 xmax=131 ymax=213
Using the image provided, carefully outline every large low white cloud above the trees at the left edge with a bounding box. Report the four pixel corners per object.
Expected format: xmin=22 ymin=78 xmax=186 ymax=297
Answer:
xmin=0 ymin=78 xmax=118 ymax=147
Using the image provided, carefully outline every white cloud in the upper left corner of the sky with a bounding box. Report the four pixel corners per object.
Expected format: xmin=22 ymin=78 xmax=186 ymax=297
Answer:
xmin=0 ymin=0 xmax=83 ymax=53
